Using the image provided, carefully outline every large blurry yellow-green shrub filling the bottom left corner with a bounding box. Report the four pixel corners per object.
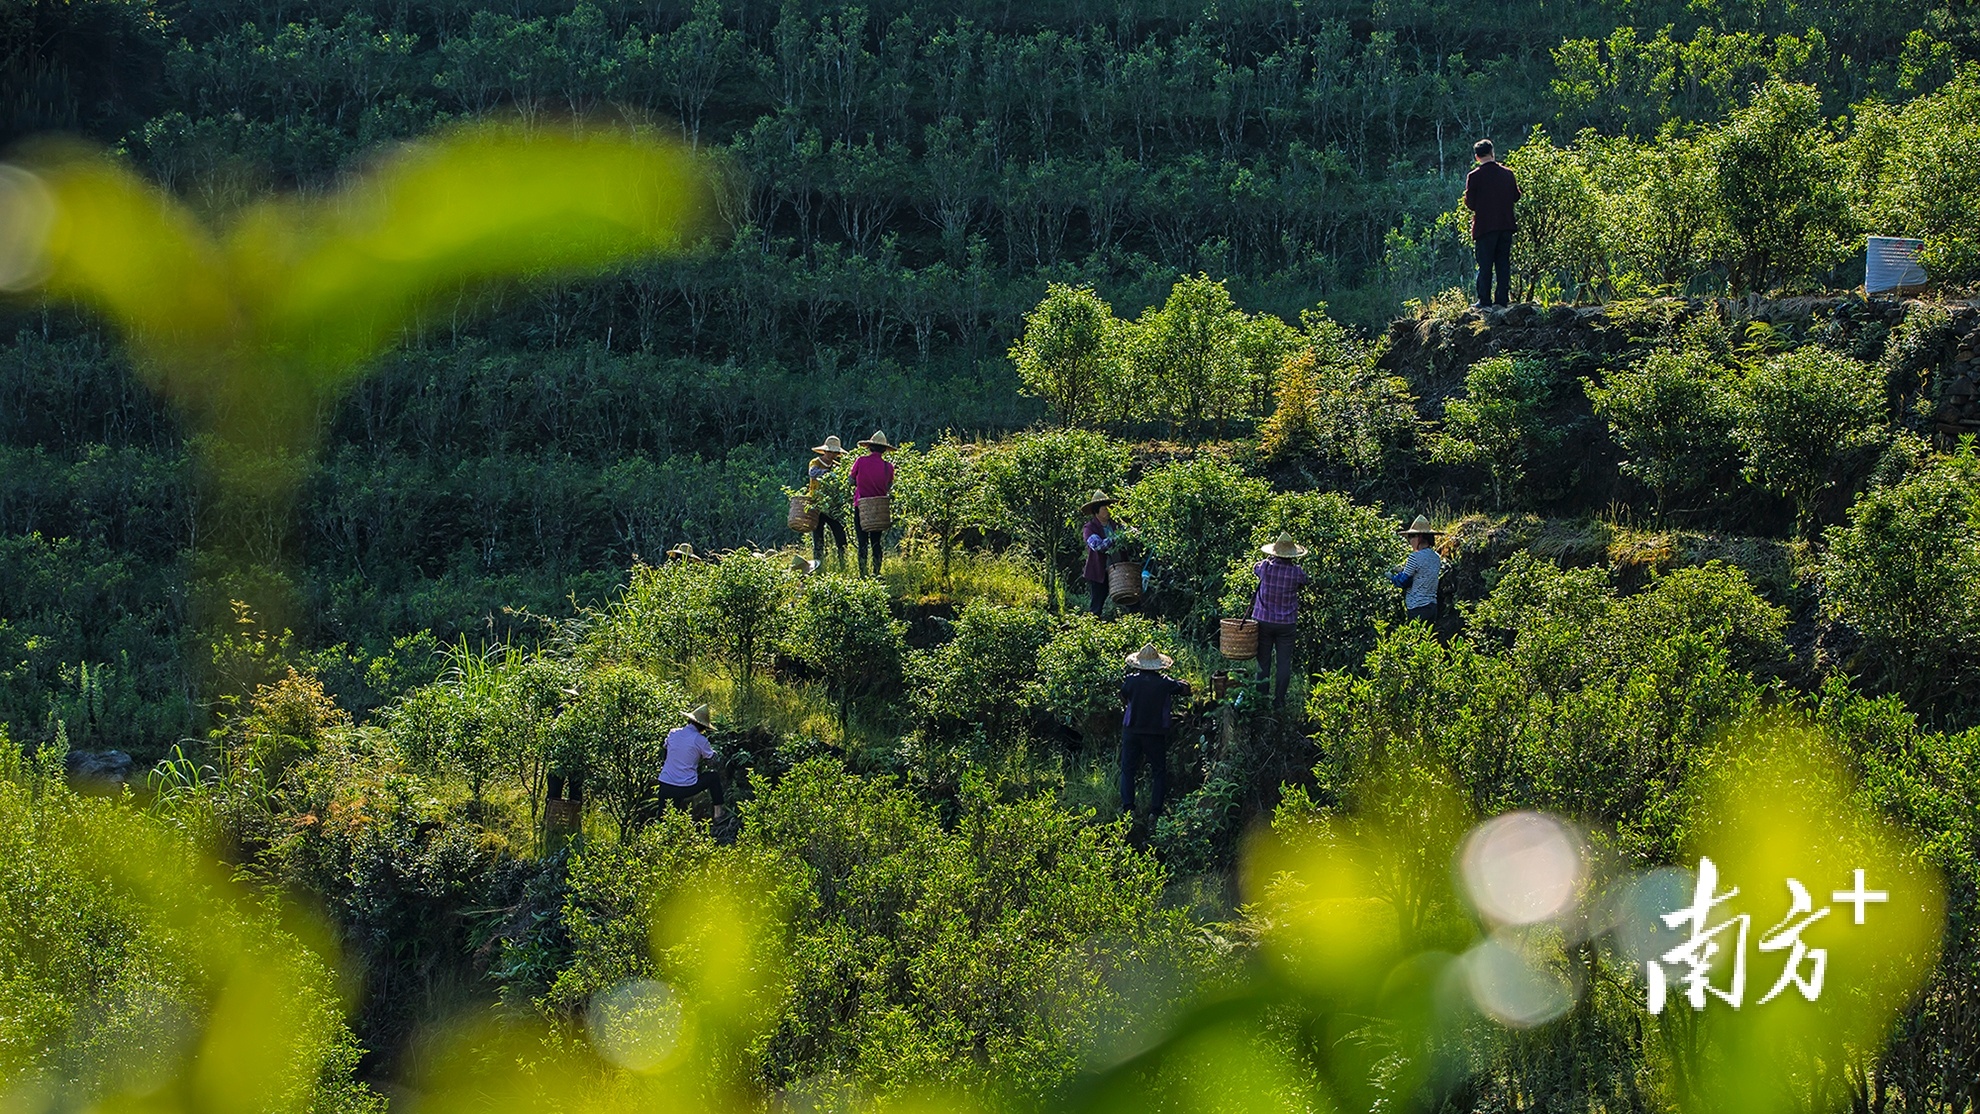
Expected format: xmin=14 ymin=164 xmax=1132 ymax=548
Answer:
xmin=0 ymin=734 xmax=384 ymax=1114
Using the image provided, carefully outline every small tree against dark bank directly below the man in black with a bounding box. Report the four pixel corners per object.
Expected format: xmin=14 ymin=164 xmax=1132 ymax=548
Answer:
xmin=1430 ymin=356 xmax=1564 ymax=507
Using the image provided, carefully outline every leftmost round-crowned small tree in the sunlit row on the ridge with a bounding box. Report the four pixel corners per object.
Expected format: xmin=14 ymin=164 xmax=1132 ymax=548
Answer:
xmin=1010 ymin=283 xmax=1121 ymax=427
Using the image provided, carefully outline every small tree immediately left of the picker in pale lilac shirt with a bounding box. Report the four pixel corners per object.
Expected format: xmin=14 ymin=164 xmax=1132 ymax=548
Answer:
xmin=556 ymin=665 xmax=687 ymax=837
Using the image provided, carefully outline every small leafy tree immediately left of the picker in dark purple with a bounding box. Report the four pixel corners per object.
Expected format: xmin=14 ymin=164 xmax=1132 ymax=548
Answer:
xmin=982 ymin=429 xmax=1127 ymax=598
